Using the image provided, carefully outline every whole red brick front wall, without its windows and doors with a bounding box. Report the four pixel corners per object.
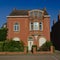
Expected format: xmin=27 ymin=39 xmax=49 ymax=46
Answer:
xmin=7 ymin=17 xmax=50 ymax=45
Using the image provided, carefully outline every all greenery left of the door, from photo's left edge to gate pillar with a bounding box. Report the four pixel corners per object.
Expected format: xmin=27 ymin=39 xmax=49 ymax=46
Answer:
xmin=0 ymin=40 xmax=24 ymax=52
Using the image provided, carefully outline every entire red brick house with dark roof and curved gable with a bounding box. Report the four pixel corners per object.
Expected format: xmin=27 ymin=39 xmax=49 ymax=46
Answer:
xmin=7 ymin=8 xmax=50 ymax=51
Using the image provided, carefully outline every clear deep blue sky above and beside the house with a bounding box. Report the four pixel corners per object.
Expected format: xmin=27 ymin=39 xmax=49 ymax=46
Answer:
xmin=0 ymin=0 xmax=60 ymax=30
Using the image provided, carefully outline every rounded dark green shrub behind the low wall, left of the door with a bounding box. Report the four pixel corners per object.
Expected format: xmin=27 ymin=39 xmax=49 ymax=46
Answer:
xmin=3 ymin=40 xmax=24 ymax=52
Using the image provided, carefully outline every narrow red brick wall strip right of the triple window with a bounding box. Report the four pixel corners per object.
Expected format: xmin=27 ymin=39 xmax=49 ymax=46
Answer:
xmin=43 ymin=18 xmax=50 ymax=40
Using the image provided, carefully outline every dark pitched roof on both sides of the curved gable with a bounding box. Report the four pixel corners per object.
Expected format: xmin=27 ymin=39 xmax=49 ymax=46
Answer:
xmin=9 ymin=9 xmax=48 ymax=16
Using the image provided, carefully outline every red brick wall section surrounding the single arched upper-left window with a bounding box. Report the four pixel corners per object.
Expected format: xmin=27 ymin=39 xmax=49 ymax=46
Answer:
xmin=7 ymin=18 xmax=28 ymax=44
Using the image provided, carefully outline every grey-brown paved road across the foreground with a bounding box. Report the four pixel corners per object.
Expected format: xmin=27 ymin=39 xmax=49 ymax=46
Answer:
xmin=0 ymin=53 xmax=60 ymax=60
